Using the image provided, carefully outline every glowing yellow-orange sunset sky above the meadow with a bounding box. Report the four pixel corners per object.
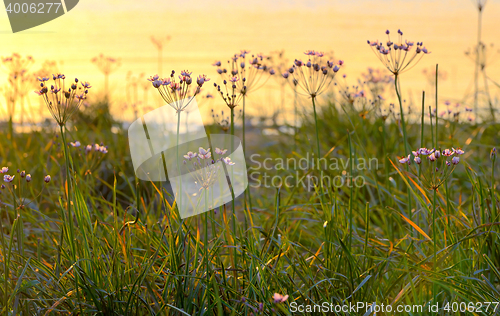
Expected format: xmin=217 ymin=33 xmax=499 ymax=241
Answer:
xmin=0 ymin=0 xmax=500 ymax=121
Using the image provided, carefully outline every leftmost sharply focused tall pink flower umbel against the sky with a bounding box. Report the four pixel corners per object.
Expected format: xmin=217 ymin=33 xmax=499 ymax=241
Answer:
xmin=35 ymin=74 xmax=92 ymax=126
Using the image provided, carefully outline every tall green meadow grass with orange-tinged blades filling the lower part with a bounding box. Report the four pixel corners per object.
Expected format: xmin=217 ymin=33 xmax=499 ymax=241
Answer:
xmin=0 ymin=81 xmax=500 ymax=315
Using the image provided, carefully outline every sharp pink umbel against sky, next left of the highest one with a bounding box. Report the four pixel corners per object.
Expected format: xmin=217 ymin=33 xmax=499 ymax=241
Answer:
xmin=282 ymin=50 xmax=344 ymax=98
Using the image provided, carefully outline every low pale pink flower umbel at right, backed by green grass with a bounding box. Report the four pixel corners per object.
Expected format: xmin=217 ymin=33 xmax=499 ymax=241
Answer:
xmin=399 ymin=148 xmax=465 ymax=190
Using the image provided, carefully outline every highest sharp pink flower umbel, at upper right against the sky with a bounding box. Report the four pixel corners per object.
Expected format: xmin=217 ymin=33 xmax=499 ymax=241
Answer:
xmin=367 ymin=30 xmax=430 ymax=75
